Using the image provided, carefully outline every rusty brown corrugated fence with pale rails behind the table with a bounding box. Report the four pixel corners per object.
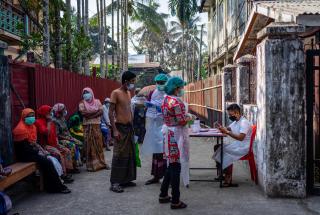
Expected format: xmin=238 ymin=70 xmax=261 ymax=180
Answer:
xmin=184 ymin=75 xmax=222 ymax=127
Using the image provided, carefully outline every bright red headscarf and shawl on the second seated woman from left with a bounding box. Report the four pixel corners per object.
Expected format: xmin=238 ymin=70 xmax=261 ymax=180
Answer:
xmin=35 ymin=105 xmax=58 ymax=147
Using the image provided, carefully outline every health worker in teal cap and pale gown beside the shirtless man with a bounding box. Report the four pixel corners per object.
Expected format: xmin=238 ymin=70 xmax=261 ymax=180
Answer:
xmin=141 ymin=74 xmax=168 ymax=185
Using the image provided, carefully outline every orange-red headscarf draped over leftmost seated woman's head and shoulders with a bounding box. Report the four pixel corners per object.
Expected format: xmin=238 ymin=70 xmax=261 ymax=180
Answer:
xmin=13 ymin=108 xmax=37 ymax=143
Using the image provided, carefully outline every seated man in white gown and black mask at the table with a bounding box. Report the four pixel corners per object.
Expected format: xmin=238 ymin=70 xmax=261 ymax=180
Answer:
xmin=214 ymin=104 xmax=252 ymax=187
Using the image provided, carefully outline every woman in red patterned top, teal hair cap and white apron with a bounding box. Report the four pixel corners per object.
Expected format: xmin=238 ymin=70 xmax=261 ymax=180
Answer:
xmin=159 ymin=77 xmax=192 ymax=209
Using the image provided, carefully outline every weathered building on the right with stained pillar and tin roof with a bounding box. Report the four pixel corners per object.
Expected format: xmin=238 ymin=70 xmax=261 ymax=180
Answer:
xmin=201 ymin=0 xmax=320 ymax=198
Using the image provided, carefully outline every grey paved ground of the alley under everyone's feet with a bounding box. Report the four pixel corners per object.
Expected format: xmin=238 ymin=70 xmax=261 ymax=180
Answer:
xmin=10 ymin=139 xmax=320 ymax=215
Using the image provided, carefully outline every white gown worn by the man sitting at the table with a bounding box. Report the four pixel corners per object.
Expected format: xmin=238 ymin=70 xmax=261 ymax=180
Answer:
xmin=214 ymin=117 xmax=252 ymax=169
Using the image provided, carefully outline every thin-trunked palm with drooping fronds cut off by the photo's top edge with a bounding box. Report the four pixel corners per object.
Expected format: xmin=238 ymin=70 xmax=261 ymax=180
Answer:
xmin=169 ymin=0 xmax=198 ymax=78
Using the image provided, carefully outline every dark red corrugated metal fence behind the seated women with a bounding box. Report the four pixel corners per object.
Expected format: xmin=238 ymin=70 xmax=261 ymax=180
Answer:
xmin=11 ymin=64 xmax=120 ymax=125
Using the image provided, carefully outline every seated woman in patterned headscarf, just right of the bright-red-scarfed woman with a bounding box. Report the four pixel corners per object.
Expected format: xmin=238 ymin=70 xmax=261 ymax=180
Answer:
xmin=52 ymin=103 xmax=83 ymax=173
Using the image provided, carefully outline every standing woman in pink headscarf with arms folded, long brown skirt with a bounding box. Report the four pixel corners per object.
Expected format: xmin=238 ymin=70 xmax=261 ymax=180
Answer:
xmin=79 ymin=87 xmax=109 ymax=172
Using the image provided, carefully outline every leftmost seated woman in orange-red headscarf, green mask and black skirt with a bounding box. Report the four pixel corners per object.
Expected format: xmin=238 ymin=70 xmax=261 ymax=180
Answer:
xmin=13 ymin=109 xmax=71 ymax=194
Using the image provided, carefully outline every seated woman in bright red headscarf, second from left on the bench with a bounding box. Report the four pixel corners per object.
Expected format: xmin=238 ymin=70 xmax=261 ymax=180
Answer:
xmin=35 ymin=105 xmax=73 ymax=183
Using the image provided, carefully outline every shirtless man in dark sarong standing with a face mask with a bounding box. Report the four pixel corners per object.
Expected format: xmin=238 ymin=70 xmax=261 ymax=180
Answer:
xmin=109 ymin=71 xmax=137 ymax=193
